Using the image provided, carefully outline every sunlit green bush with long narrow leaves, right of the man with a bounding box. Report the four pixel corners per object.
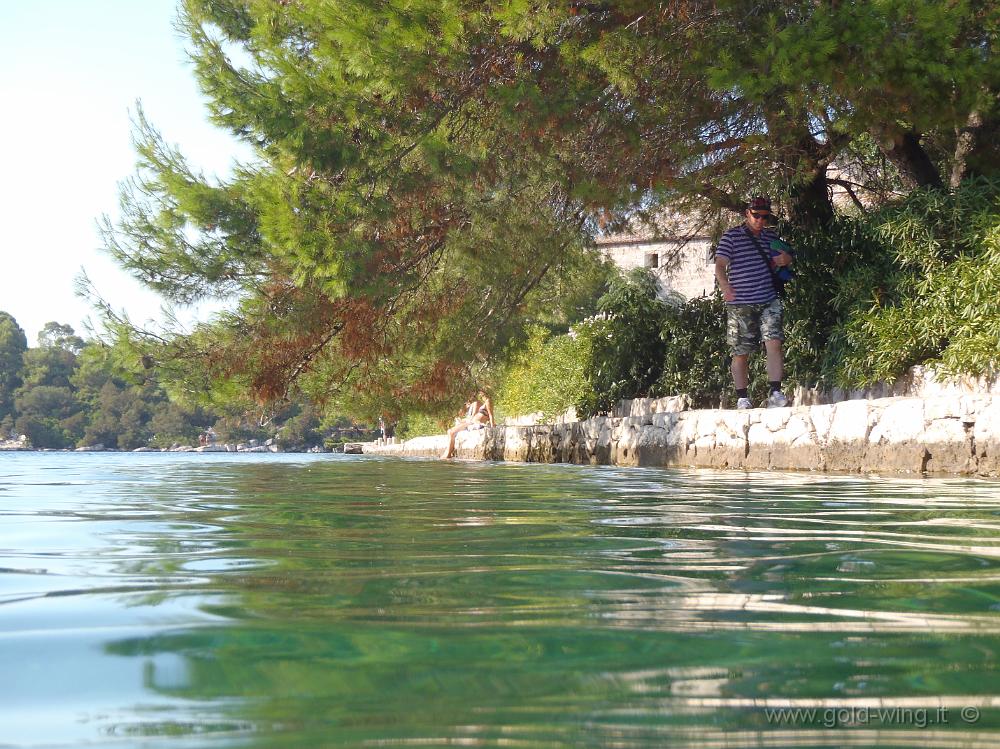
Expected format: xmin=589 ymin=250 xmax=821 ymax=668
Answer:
xmin=828 ymin=179 xmax=1000 ymax=386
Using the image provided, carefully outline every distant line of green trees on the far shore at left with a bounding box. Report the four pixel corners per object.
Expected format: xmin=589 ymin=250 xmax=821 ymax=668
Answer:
xmin=0 ymin=311 xmax=370 ymax=450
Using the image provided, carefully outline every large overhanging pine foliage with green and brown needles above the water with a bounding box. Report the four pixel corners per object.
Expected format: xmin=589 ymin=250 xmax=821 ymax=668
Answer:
xmin=95 ymin=0 xmax=1000 ymax=418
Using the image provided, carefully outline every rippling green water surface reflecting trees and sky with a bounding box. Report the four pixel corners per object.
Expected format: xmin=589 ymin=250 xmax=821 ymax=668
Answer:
xmin=0 ymin=453 xmax=1000 ymax=749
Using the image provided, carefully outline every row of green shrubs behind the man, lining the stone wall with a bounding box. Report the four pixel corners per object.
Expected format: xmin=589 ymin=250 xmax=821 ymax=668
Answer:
xmin=494 ymin=179 xmax=1000 ymax=426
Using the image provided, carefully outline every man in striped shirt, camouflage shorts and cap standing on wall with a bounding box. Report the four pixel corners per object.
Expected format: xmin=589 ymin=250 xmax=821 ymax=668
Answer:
xmin=715 ymin=197 xmax=792 ymax=408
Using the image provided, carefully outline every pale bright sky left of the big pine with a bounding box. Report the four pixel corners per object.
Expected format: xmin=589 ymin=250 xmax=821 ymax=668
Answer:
xmin=0 ymin=0 xmax=249 ymax=346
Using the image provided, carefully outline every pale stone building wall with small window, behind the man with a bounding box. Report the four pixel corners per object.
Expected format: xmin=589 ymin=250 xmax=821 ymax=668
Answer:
xmin=599 ymin=238 xmax=715 ymax=299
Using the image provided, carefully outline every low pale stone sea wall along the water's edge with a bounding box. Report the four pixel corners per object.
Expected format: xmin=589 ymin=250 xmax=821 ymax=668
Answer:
xmin=364 ymin=393 xmax=1000 ymax=476
